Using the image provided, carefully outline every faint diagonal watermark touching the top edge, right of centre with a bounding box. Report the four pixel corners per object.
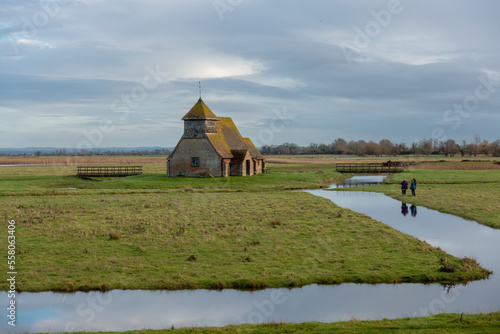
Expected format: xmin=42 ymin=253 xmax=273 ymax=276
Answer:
xmin=340 ymin=0 xmax=412 ymax=63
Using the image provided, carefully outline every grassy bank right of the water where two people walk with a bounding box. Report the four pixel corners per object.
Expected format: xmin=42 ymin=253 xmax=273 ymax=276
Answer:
xmin=348 ymin=169 xmax=500 ymax=228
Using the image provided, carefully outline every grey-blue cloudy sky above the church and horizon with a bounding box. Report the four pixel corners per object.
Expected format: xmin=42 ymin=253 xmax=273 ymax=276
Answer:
xmin=0 ymin=0 xmax=500 ymax=148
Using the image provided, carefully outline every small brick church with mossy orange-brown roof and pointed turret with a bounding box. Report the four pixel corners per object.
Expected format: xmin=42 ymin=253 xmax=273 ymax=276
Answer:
xmin=167 ymin=98 xmax=266 ymax=177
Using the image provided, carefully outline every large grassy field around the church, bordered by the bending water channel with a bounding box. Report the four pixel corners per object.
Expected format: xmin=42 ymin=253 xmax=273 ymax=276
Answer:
xmin=0 ymin=158 xmax=488 ymax=291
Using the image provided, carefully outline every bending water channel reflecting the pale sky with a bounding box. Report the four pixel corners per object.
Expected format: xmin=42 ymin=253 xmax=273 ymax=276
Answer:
xmin=0 ymin=177 xmax=500 ymax=333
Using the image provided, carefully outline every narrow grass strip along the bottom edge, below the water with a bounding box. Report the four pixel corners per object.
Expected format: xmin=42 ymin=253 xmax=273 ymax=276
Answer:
xmin=44 ymin=312 xmax=500 ymax=334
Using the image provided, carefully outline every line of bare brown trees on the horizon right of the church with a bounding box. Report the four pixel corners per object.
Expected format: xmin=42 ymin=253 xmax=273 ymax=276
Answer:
xmin=260 ymin=136 xmax=500 ymax=157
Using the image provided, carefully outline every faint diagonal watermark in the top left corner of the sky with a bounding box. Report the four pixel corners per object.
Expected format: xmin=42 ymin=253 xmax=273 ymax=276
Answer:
xmin=8 ymin=0 xmax=74 ymax=54
